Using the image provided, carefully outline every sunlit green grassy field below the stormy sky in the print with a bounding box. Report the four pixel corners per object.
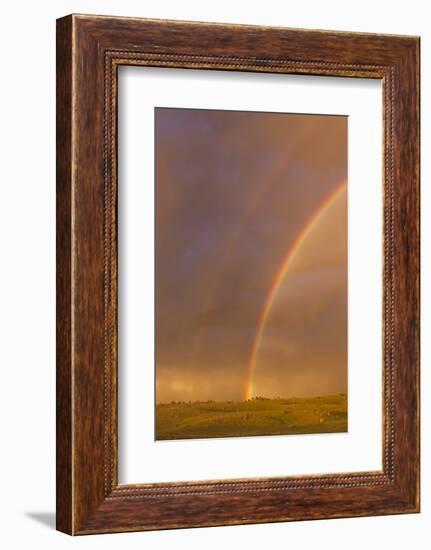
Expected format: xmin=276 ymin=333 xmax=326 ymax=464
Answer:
xmin=156 ymin=394 xmax=347 ymax=440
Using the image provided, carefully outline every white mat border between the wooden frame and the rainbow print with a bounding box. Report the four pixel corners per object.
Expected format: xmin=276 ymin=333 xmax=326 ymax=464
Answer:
xmin=118 ymin=67 xmax=383 ymax=483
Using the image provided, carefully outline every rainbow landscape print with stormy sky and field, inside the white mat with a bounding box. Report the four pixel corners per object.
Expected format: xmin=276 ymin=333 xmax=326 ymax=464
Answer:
xmin=155 ymin=107 xmax=348 ymax=440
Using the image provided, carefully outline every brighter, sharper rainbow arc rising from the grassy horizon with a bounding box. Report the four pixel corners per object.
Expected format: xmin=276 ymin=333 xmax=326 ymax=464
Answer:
xmin=244 ymin=180 xmax=347 ymax=400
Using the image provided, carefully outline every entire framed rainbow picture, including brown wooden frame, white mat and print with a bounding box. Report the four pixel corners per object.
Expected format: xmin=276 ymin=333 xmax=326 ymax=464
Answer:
xmin=57 ymin=15 xmax=419 ymax=535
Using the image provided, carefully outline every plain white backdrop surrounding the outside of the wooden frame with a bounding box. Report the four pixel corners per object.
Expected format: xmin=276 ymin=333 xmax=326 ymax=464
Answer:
xmin=0 ymin=0 xmax=431 ymax=550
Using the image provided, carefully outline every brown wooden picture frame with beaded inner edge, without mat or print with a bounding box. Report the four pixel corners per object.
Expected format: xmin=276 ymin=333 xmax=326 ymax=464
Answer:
xmin=57 ymin=15 xmax=419 ymax=535
